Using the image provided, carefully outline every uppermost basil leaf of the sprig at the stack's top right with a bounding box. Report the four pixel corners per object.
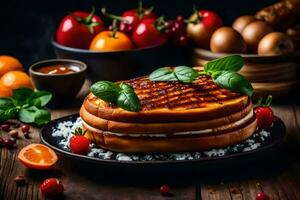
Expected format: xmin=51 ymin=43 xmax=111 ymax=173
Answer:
xmin=204 ymin=55 xmax=244 ymax=74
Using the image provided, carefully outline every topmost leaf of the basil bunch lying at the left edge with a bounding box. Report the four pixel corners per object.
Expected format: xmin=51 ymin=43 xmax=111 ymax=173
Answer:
xmin=12 ymin=88 xmax=34 ymax=106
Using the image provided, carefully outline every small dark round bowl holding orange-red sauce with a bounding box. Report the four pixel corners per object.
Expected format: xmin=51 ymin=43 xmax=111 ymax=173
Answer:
xmin=29 ymin=59 xmax=87 ymax=102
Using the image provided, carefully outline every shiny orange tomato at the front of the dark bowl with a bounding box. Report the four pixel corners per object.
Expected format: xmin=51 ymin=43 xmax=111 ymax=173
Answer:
xmin=90 ymin=31 xmax=133 ymax=51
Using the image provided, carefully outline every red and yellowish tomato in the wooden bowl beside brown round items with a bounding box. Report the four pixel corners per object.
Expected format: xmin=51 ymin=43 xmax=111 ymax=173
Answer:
xmin=187 ymin=10 xmax=223 ymax=49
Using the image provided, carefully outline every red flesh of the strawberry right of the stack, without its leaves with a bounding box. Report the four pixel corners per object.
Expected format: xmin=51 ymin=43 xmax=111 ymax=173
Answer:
xmin=254 ymin=106 xmax=274 ymax=129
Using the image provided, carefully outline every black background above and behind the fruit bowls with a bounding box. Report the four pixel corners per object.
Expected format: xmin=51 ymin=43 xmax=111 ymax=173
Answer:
xmin=0 ymin=0 xmax=276 ymax=68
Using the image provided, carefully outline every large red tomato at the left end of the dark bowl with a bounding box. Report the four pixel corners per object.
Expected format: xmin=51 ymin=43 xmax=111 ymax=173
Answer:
xmin=56 ymin=10 xmax=105 ymax=49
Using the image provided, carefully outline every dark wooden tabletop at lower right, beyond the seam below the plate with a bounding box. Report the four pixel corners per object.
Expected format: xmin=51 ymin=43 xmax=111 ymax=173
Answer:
xmin=201 ymin=105 xmax=300 ymax=200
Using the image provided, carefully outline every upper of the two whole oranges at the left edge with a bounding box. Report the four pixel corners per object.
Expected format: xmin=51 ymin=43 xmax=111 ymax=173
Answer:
xmin=0 ymin=55 xmax=23 ymax=77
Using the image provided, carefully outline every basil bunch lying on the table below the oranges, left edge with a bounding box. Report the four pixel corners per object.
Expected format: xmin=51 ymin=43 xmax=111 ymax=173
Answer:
xmin=0 ymin=88 xmax=52 ymax=125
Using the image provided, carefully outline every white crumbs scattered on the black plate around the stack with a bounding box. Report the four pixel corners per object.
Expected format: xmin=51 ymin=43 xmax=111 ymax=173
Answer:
xmin=52 ymin=118 xmax=271 ymax=161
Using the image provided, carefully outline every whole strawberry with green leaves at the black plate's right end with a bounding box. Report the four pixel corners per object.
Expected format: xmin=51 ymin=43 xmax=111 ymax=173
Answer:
xmin=254 ymin=96 xmax=274 ymax=129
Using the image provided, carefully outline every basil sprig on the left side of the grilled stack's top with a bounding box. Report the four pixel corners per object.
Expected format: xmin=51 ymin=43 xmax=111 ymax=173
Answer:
xmin=90 ymin=81 xmax=140 ymax=112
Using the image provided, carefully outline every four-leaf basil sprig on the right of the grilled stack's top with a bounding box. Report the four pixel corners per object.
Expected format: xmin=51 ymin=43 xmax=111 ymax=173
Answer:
xmin=149 ymin=55 xmax=253 ymax=96
